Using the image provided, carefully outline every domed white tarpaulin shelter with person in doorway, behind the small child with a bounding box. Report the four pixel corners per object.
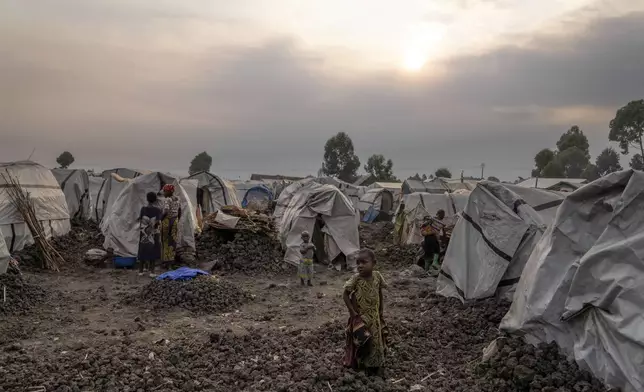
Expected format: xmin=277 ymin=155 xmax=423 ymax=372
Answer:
xmin=274 ymin=180 xmax=360 ymax=268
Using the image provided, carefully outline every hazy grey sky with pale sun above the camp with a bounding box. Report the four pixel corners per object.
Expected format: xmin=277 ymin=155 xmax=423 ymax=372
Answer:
xmin=0 ymin=0 xmax=644 ymax=180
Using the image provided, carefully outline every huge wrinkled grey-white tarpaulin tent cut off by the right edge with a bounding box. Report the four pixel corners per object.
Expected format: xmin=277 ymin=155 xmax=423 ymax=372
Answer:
xmin=501 ymin=170 xmax=644 ymax=392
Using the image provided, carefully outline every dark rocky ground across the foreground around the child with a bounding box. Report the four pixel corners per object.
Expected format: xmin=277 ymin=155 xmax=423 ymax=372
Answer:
xmin=0 ymin=224 xmax=604 ymax=392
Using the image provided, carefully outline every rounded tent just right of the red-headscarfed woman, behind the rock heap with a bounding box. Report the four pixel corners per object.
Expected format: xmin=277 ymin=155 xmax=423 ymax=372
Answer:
xmin=182 ymin=172 xmax=241 ymax=215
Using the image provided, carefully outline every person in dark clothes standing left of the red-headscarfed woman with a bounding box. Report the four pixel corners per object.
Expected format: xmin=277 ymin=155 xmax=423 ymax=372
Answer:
xmin=138 ymin=192 xmax=163 ymax=277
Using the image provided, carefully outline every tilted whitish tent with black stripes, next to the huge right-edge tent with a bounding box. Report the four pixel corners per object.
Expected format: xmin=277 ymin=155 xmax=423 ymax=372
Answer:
xmin=436 ymin=181 xmax=563 ymax=300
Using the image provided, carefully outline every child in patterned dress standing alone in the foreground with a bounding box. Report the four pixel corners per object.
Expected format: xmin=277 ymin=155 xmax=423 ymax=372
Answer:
xmin=343 ymin=249 xmax=387 ymax=376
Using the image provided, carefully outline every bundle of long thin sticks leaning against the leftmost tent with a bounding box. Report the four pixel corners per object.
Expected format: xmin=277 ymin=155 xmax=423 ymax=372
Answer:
xmin=0 ymin=170 xmax=65 ymax=271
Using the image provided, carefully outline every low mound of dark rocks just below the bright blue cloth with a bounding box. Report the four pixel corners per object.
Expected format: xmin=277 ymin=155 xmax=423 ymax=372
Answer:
xmin=125 ymin=275 xmax=252 ymax=314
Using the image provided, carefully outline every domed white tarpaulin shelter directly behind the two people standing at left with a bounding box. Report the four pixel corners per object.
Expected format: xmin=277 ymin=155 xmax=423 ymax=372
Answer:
xmin=101 ymin=172 xmax=197 ymax=257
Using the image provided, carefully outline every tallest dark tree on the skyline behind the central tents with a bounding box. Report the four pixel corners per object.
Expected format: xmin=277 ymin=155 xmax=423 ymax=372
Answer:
xmin=322 ymin=132 xmax=360 ymax=182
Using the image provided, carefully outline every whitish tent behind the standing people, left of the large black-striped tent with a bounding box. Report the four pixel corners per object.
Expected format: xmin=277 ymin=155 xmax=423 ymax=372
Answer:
xmin=394 ymin=192 xmax=469 ymax=244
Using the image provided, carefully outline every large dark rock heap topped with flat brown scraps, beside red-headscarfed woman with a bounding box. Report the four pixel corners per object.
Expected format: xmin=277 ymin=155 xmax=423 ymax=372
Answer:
xmin=197 ymin=207 xmax=285 ymax=275
